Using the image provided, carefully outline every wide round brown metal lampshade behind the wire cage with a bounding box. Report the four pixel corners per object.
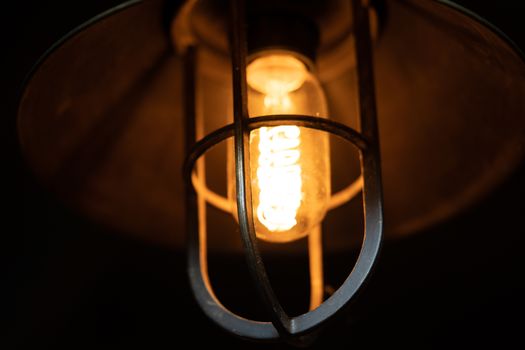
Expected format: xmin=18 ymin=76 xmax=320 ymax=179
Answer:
xmin=18 ymin=0 xmax=525 ymax=251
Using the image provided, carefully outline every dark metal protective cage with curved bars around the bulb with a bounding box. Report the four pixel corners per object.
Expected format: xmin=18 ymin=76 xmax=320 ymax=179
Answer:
xmin=184 ymin=0 xmax=383 ymax=345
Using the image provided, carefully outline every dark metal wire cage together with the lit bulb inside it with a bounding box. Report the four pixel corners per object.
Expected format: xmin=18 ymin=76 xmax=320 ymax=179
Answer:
xmin=185 ymin=1 xmax=383 ymax=344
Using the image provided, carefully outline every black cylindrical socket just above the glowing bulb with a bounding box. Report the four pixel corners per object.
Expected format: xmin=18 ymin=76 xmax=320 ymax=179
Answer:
xmin=246 ymin=13 xmax=319 ymax=63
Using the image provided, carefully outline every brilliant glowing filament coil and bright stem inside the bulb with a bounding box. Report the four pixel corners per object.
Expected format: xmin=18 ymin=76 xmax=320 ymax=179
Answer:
xmin=247 ymin=55 xmax=307 ymax=232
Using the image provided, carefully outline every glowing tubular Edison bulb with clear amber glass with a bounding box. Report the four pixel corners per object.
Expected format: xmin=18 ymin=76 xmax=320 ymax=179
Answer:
xmin=228 ymin=52 xmax=330 ymax=242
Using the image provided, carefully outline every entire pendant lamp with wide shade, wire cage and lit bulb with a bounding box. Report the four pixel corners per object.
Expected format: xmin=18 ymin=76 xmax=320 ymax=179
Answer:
xmin=18 ymin=0 xmax=525 ymax=345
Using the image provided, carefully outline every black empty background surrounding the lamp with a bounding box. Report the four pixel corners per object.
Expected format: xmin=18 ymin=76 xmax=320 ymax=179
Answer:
xmin=6 ymin=0 xmax=525 ymax=349
